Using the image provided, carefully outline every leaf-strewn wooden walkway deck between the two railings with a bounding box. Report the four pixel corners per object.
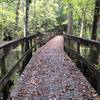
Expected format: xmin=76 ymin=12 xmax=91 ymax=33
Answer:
xmin=10 ymin=36 xmax=100 ymax=100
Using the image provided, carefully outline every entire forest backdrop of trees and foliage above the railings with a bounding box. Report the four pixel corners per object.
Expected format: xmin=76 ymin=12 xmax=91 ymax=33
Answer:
xmin=0 ymin=0 xmax=100 ymax=40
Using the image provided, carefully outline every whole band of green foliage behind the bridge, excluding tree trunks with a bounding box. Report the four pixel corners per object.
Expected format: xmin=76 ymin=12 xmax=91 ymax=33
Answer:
xmin=0 ymin=0 xmax=95 ymax=38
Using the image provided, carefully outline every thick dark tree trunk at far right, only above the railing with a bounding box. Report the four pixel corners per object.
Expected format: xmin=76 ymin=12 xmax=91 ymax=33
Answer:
xmin=91 ymin=0 xmax=100 ymax=40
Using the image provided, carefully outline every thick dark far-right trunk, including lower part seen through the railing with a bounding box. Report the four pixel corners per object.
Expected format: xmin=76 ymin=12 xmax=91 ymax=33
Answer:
xmin=90 ymin=0 xmax=100 ymax=64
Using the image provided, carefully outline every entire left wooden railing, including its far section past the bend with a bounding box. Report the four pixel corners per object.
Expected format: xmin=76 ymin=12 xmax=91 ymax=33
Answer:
xmin=0 ymin=34 xmax=54 ymax=100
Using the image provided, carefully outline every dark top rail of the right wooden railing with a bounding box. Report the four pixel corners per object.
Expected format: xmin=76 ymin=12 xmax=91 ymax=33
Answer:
xmin=64 ymin=35 xmax=100 ymax=48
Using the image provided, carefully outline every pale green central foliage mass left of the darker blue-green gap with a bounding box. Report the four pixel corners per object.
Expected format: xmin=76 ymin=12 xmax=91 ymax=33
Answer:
xmin=30 ymin=0 xmax=57 ymax=32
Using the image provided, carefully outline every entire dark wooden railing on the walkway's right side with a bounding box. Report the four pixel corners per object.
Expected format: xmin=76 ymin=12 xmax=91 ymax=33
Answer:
xmin=64 ymin=35 xmax=100 ymax=94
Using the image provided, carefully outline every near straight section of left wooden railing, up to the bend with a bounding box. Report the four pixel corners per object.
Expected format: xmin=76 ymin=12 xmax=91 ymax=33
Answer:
xmin=0 ymin=35 xmax=36 ymax=99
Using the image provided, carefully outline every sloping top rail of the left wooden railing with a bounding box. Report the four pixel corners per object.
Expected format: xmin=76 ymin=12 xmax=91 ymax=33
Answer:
xmin=0 ymin=34 xmax=38 ymax=49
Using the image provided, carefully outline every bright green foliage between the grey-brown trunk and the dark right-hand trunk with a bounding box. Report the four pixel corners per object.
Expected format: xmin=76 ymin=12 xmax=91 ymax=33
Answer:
xmin=63 ymin=0 xmax=95 ymax=38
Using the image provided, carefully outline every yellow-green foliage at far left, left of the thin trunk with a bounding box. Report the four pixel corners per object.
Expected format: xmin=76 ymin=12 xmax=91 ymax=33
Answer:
xmin=0 ymin=1 xmax=15 ymax=39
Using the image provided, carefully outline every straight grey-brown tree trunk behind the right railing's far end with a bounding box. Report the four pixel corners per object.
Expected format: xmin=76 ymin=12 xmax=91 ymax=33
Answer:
xmin=67 ymin=4 xmax=73 ymax=35
